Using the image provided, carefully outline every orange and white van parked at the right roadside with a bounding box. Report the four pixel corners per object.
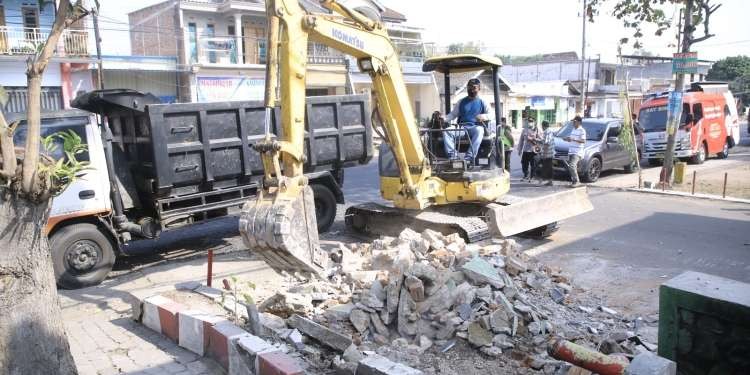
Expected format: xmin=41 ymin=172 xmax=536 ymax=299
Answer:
xmin=638 ymin=82 xmax=740 ymax=165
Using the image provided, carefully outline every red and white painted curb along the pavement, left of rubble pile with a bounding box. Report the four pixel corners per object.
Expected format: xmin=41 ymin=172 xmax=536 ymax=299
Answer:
xmin=133 ymin=295 xmax=304 ymax=375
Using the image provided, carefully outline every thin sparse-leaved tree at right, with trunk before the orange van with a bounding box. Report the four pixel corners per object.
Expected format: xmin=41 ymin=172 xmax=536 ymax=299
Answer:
xmin=587 ymin=0 xmax=721 ymax=185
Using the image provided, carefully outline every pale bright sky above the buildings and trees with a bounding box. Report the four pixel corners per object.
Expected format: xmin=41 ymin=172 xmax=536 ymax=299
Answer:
xmin=99 ymin=0 xmax=750 ymax=62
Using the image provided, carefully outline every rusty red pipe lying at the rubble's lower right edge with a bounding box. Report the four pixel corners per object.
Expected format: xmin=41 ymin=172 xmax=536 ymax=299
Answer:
xmin=547 ymin=340 xmax=630 ymax=375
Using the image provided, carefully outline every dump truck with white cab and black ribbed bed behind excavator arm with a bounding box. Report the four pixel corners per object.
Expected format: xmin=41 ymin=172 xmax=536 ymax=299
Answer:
xmin=8 ymin=89 xmax=373 ymax=288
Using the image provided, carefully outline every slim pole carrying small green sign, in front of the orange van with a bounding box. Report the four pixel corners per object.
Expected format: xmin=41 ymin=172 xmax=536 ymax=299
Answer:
xmin=660 ymin=0 xmax=693 ymax=185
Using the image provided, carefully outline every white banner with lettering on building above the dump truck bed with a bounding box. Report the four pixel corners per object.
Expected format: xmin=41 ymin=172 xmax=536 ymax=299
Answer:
xmin=197 ymin=77 xmax=265 ymax=103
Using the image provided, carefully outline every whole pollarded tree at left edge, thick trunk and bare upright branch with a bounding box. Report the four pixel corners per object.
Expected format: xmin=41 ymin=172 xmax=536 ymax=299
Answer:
xmin=0 ymin=0 xmax=88 ymax=374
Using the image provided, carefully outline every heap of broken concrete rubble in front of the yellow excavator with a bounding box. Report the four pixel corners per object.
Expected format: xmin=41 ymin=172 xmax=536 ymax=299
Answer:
xmin=251 ymin=229 xmax=652 ymax=373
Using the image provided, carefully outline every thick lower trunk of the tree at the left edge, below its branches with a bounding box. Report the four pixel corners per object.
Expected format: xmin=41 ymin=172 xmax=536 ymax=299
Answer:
xmin=0 ymin=188 xmax=77 ymax=375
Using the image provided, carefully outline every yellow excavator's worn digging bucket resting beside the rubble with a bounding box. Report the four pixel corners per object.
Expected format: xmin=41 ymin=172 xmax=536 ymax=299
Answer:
xmin=240 ymin=186 xmax=328 ymax=277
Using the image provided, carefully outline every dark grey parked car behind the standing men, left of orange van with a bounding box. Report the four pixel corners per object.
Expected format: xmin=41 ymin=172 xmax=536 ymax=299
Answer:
xmin=553 ymin=118 xmax=637 ymax=182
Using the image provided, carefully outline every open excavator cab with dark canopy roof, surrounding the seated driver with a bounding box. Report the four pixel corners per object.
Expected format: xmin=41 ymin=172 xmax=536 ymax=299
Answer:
xmin=420 ymin=55 xmax=505 ymax=180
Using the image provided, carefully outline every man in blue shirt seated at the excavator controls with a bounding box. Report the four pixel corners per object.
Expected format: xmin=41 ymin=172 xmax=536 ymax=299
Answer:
xmin=443 ymin=78 xmax=490 ymax=165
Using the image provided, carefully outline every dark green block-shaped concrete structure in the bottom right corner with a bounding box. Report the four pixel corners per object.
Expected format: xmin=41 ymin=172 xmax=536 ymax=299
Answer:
xmin=658 ymin=271 xmax=750 ymax=375
